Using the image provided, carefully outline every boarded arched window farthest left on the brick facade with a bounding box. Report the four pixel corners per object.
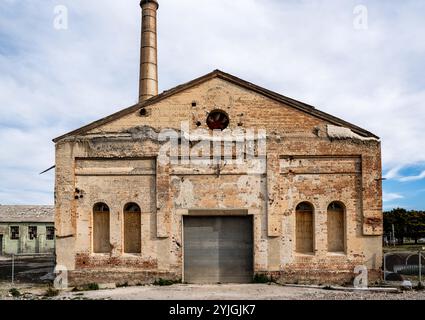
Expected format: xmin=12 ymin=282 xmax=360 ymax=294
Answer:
xmin=93 ymin=203 xmax=111 ymax=253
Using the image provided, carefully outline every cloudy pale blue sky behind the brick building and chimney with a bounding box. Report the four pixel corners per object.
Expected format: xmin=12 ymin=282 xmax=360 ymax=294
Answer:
xmin=0 ymin=0 xmax=425 ymax=209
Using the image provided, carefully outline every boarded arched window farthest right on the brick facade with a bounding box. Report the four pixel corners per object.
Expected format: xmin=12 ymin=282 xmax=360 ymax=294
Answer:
xmin=328 ymin=202 xmax=345 ymax=252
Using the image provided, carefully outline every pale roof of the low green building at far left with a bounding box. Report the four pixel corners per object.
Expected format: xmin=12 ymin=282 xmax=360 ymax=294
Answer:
xmin=0 ymin=205 xmax=55 ymax=223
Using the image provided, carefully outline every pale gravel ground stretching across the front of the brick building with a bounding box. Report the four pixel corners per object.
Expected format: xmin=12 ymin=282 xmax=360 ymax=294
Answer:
xmin=0 ymin=284 xmax=425 ymax=300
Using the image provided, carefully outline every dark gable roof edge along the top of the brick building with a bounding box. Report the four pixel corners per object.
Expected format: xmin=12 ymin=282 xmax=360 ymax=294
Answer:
xmin=53 ymin=70 xmax=379 ymax=143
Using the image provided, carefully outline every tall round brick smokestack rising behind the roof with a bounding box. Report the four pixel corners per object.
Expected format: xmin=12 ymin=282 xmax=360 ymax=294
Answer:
xmin=139 ymin=0 xmax=159 ymax=102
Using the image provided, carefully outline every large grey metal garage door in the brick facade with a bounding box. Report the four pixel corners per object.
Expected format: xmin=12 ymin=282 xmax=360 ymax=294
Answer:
xmin=184 ymin=217 xmax=253 ymax=283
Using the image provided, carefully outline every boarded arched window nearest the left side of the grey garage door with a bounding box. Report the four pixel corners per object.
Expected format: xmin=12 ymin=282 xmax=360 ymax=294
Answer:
xmin=124 ymin=203 xmax=142 ymax=253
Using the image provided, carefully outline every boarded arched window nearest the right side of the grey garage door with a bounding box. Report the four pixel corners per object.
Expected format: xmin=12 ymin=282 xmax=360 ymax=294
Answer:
xmin=295 ymin=202 xmax=314 ymax=253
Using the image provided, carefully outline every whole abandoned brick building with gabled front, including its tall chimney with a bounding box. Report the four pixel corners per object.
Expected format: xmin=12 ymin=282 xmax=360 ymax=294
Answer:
xmin=54 ymin=0 xmax=382 ymax=283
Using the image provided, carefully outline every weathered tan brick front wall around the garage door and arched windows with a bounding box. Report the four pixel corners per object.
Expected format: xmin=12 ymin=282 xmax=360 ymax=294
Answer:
xmin=56 ymin=79 xmax=382 ymax=282
